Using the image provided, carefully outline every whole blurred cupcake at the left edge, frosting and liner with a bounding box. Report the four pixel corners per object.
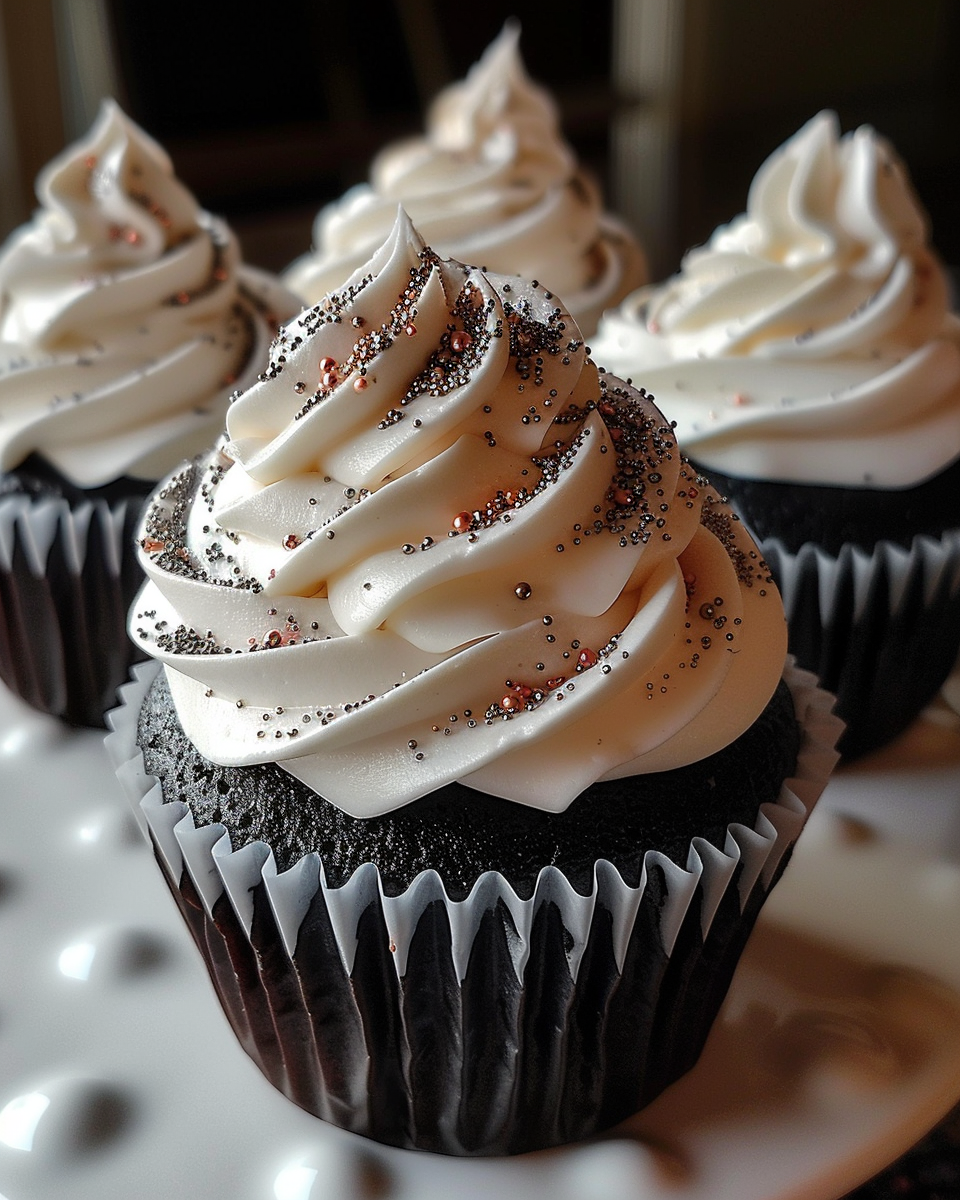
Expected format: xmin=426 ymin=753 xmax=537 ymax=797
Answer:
xmin=0 ymin=101 xmax=298 ymax=725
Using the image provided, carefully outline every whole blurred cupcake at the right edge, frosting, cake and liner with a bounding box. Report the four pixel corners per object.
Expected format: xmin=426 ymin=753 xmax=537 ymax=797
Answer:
xmin=592 ymin=113 xmax=960 ymax=756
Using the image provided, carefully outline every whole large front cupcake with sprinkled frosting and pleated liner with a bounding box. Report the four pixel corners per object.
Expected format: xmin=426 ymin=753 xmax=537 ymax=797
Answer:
xmin=108 ymin=214 xmax=836 ymax=1154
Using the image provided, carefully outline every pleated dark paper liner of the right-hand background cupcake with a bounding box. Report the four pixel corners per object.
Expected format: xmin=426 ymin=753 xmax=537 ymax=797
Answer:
xmin=761 ymin=530 xmax=960 ymax=758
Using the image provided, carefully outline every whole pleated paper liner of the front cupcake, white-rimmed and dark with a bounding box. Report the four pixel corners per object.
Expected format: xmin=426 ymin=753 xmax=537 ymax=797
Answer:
xmin=107 ymin=665 xmax=839 ymax=1154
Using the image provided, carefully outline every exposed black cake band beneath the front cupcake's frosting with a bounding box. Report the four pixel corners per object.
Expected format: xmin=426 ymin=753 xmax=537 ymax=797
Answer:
xmin=138 ymin=672 xmax=799 ymax=900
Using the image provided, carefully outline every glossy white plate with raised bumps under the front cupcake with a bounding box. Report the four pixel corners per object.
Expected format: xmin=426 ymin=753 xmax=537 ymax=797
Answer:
xmin=0 ymin=692 xmax=960 ymax=1200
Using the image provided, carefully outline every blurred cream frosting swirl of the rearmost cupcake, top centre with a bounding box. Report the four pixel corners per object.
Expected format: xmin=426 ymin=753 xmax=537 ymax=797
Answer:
xmin=286 ymin=23 xmax=646 ymax=334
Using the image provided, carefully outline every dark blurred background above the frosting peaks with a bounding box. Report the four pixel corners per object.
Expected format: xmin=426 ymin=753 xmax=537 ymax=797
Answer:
xmin=0 ymin=0 xmax=960 ymax=277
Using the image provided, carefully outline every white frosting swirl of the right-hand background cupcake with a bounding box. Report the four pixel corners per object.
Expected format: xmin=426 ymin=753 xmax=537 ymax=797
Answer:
xmin=592 ymin=113 xmax=960 ymax=488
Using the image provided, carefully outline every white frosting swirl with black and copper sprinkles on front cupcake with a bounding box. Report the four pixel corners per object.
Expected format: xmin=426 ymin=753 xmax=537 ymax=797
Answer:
xmin=131 ymin=212 xmax=786 ymax=816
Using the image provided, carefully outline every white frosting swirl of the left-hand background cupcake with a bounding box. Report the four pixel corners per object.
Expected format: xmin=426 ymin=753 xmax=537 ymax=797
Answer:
xmin=0 ymin=101 xmax=299 ymax=487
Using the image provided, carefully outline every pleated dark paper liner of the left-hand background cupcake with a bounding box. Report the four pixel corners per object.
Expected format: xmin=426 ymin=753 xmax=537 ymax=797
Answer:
xmin=0 ymin=494 xmax=144 ymax=726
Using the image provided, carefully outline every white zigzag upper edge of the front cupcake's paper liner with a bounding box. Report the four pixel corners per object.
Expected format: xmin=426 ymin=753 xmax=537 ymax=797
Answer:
xmin=106 ymin=658 xmax=842 ymax=980
